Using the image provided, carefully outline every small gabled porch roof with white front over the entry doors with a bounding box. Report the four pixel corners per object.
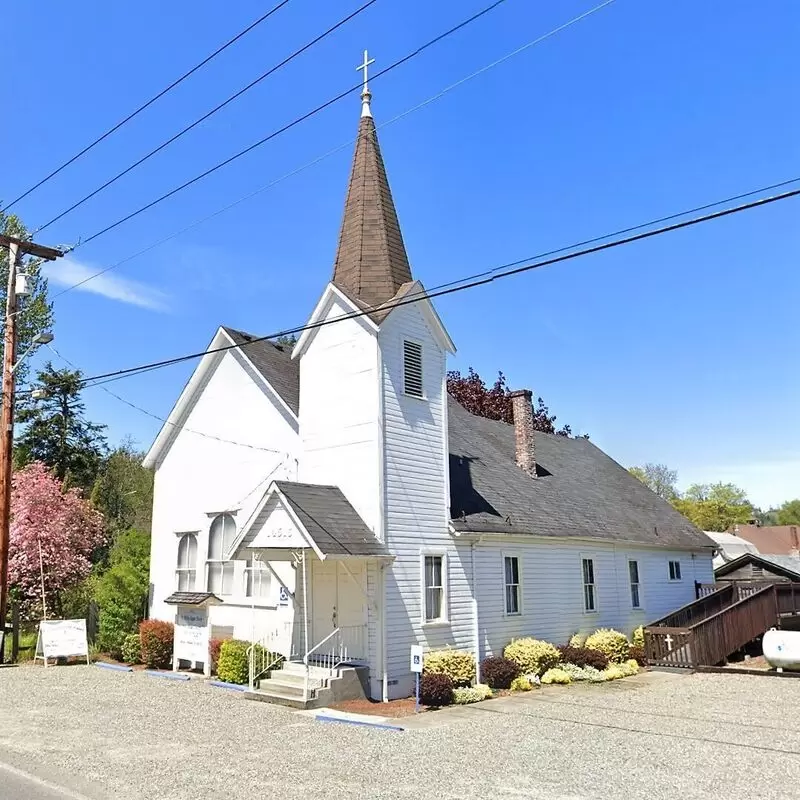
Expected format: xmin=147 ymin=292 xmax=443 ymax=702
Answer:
xmin=232 ymin=481 xmax=389 ymax=559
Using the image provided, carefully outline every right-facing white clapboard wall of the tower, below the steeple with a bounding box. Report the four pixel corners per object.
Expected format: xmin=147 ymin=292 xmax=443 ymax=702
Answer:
xmin=379 ymin=305 xmax=471 ymax=697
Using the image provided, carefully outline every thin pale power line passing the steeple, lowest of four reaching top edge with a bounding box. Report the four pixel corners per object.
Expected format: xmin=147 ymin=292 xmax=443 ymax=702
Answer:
xmin=52 ymin=0 xmax=616 ymax=300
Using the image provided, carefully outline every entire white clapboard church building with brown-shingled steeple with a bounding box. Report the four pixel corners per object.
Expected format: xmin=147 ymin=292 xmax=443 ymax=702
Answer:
xmin=145 ymin=65 xmax=714 ymax=700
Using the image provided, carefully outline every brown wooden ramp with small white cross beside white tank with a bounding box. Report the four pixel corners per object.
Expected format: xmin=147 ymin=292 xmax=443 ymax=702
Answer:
xmin=644 ymin=582 xmax=800 ymax=669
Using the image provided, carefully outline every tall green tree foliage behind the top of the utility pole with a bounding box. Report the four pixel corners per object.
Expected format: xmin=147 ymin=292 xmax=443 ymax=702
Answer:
xmin=0 ymin=213 xmax=53 ymax=384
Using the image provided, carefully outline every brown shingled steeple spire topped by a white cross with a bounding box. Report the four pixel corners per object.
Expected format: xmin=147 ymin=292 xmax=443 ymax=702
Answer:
xmin=333 ymin=51 xmax=413 ymax=306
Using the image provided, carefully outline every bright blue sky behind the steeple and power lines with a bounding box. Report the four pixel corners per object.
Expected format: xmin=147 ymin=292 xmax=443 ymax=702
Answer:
xmin=6 ymin=0 xmax=800 ymax=506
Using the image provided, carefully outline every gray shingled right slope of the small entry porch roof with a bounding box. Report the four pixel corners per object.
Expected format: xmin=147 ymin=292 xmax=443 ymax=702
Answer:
xmin=275 ymin=481 xmax=387 ymax=556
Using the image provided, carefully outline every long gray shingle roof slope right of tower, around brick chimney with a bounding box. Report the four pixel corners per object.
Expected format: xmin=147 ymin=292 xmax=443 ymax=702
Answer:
xmin=448 ymin=398 xmax=714 ymax=548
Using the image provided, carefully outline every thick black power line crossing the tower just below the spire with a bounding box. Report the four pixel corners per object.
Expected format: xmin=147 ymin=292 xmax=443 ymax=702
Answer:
xmin=72 ymin=178 xmax=800 ymax=394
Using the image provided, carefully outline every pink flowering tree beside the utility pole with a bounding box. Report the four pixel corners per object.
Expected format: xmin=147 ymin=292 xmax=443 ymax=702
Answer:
xmin=8 ymin=462 xmax=105 ymax=616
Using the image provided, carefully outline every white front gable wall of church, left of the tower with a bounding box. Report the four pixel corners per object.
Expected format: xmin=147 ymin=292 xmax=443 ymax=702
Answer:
xmin=150 ymin=351 xmax=299 ymax=638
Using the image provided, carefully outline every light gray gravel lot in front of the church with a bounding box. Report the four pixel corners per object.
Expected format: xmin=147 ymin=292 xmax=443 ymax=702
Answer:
xmin=0 ymin=666 xmax=800 ymax=800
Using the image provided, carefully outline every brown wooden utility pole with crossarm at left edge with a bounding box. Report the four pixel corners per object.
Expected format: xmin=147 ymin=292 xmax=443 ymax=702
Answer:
xmin=0 ymin=234 xmax=63 ymax=663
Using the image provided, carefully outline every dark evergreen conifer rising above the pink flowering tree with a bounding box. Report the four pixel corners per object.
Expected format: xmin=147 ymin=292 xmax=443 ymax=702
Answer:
xmin=15 ymin=362 xmax=106 ymax=492
